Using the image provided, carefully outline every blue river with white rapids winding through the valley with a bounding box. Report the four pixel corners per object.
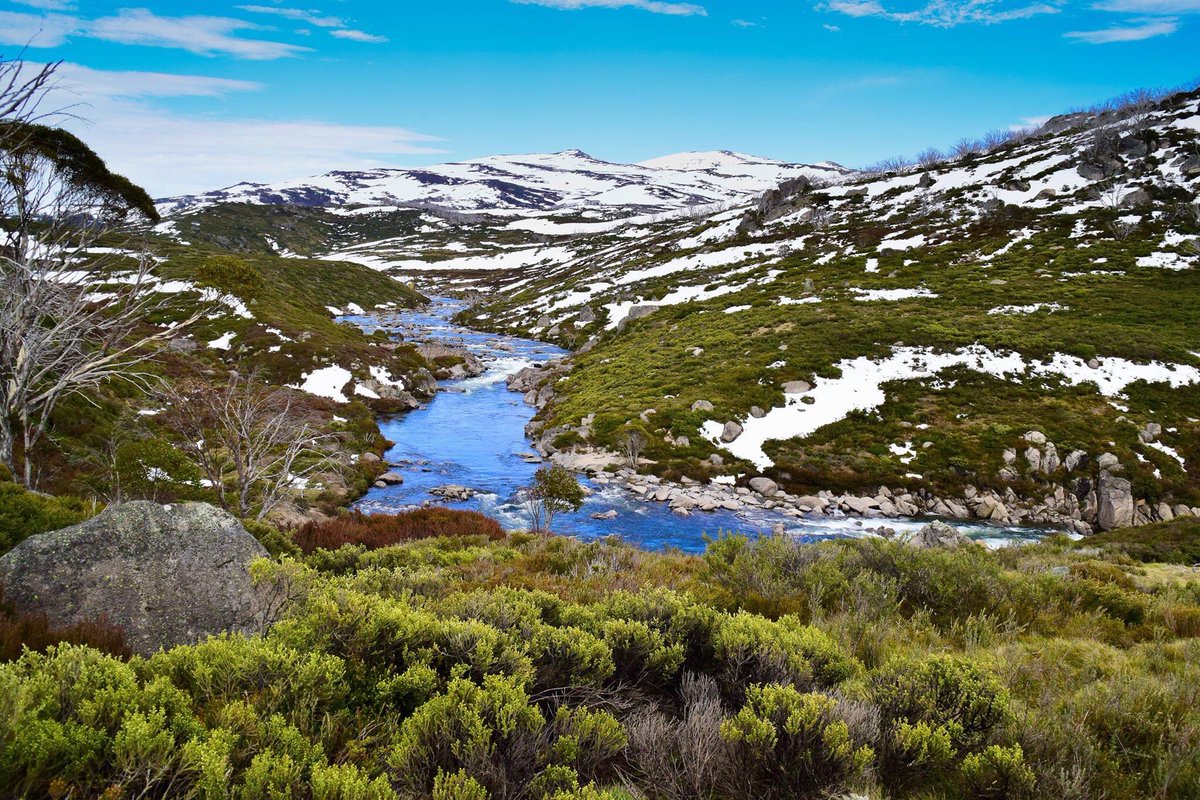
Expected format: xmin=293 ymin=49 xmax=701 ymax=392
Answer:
xmin=342 ymin=299 xmax=1038 ymax=553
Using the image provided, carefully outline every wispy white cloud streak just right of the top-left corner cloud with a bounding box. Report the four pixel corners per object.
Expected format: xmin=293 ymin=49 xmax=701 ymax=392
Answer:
xmin=86 ymin=8 xmax=308 ymax=61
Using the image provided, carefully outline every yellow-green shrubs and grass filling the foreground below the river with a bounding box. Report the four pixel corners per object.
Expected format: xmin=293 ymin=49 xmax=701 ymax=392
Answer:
xmin=0 ymin=513 xmax=1200 ymax=800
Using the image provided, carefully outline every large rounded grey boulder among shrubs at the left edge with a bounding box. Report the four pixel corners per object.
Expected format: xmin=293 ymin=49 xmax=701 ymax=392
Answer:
xmin=0 ymin=501 xmax=271 ymax=655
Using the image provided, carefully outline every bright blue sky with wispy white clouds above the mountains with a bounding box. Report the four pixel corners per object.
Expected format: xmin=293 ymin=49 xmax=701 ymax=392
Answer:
xmin=0 ymin=0 xmax=1200 ymax=196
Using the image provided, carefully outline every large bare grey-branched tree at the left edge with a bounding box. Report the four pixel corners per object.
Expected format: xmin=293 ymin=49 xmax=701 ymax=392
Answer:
xmin=0 ymin=60 xmax=200 ymax=486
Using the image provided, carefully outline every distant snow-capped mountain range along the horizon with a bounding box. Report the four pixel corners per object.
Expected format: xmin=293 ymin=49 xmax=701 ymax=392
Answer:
xmin=160 ymin=150 xmax=853 ymax=216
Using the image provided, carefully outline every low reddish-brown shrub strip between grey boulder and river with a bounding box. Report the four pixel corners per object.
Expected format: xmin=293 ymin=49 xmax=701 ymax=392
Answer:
xmin=293 ymin=509 xmax=504 ymax=553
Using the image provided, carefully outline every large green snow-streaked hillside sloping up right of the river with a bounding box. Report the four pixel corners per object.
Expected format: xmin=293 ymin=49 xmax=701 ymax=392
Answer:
xmin=451 ymin=92 xmax=1200 ymax=522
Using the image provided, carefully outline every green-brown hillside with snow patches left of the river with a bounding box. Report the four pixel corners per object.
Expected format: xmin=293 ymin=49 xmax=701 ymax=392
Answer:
xmin=24 ymin=235 xmax=433 ymax=509
